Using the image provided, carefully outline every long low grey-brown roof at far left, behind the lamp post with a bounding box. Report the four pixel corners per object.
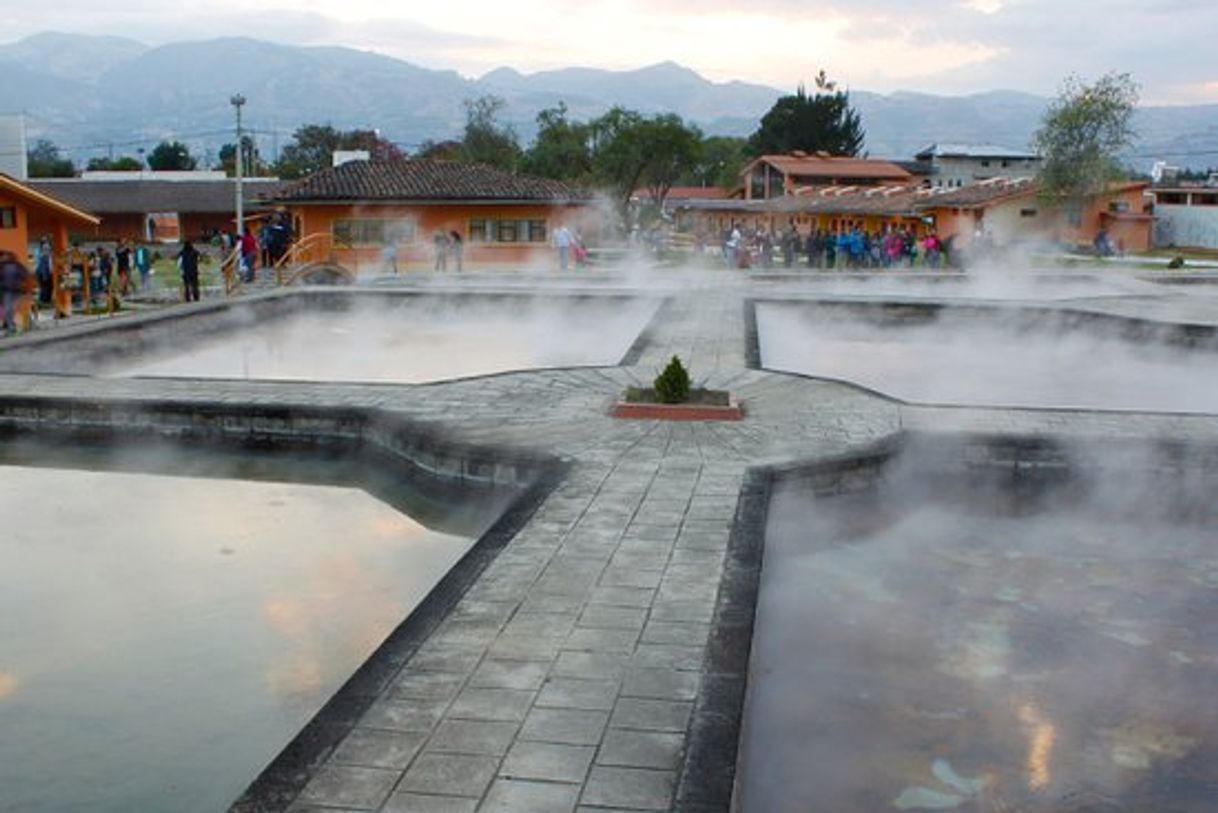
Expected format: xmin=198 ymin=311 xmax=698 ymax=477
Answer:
xmin=29 ymin=178 xmax=283 ymax=215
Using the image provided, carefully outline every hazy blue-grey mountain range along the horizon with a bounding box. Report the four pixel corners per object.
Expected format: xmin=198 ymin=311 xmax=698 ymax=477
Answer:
xmin=0 ymin=32 xmax=1218 ymax=169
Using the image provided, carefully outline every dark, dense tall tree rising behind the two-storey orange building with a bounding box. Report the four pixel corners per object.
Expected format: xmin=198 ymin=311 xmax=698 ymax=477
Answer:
xmin=749 ymin=71 xmax=864 ymax=156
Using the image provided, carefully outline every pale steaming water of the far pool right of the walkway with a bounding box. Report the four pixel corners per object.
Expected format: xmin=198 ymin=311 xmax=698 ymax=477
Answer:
xmin=756 ymin=304 xmax=1218 ymax=413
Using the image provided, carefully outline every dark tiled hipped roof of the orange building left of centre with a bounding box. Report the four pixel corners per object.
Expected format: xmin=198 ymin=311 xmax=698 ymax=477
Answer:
xmin=275 ymin=158 xmax=591 ymax=202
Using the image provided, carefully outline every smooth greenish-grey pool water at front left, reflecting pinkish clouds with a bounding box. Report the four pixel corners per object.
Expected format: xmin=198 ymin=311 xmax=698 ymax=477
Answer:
xmin=0 ymin=455 xmax=496 ymax=813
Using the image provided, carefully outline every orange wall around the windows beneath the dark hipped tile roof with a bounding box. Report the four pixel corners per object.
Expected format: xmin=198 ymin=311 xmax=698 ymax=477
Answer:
xmin=287 ymin=204 xmax=599 ymax=271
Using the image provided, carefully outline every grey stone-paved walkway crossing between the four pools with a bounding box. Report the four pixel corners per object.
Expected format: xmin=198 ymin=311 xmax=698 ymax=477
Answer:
xmin=0 ymin=270 xmax=1218 ymax=813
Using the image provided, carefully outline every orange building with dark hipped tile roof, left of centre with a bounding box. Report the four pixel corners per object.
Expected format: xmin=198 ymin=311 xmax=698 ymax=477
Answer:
xmin=273 ymin=158 xmax=599 ymax=273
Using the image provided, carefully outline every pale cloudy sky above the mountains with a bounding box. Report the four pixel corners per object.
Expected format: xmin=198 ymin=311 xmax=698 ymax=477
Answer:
xmin=0 ymin=0 xmax=1218 ymax=104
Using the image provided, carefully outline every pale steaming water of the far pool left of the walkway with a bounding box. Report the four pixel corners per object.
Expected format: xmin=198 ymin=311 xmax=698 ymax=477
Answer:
xmin=107 ymin=300 xmax=657 ymax=383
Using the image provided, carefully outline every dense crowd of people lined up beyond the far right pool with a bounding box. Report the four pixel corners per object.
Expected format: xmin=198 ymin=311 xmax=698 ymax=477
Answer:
xmin=703 ymin=224 xmax=950 ymax=269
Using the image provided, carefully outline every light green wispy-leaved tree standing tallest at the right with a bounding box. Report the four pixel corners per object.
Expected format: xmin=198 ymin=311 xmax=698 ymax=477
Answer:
xmin=1033 ymin=73 xmax=1138 ymax=211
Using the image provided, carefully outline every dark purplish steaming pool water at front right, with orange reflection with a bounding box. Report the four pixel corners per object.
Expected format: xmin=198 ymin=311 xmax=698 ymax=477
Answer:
xmin=741 ymin=472 xmax=1218 ymax=813
